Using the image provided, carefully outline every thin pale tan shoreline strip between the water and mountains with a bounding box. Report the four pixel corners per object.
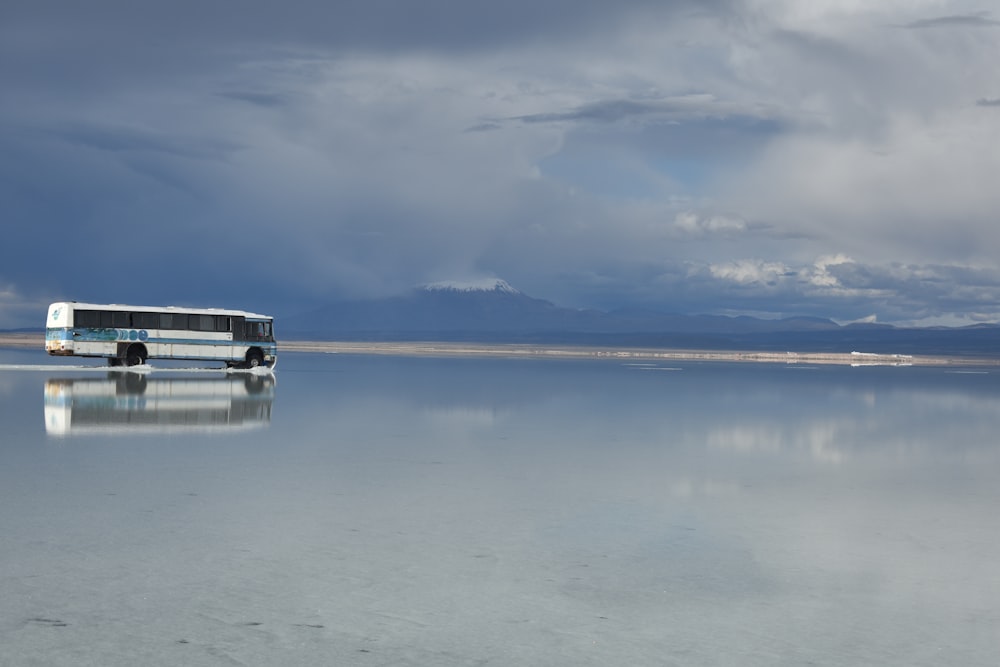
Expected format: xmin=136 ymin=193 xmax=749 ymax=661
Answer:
xmin=0 ymin=333 xmax=1000 ymax=366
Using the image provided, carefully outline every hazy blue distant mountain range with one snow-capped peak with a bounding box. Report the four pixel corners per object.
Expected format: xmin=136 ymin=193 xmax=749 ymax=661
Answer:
xmin=279 ymin=280 xmax=1000 ymax=356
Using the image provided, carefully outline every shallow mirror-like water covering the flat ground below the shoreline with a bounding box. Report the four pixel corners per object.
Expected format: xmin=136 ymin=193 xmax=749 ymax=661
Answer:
xmin=0 ymin=351 xmax=1000 ymax=665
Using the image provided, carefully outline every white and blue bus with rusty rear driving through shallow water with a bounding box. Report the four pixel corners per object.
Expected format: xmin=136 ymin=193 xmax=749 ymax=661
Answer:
xmin=45 ymin=301 xmax=278 ymax=368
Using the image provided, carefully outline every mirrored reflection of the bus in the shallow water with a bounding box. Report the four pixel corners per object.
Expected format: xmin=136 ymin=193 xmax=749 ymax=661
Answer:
xmin=45 ymin=372 xmax=274 ymax=436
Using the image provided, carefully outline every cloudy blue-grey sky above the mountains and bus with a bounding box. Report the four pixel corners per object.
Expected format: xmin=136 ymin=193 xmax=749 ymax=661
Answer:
xmin=0 ymin=0 xmax=1000 ymax=328
